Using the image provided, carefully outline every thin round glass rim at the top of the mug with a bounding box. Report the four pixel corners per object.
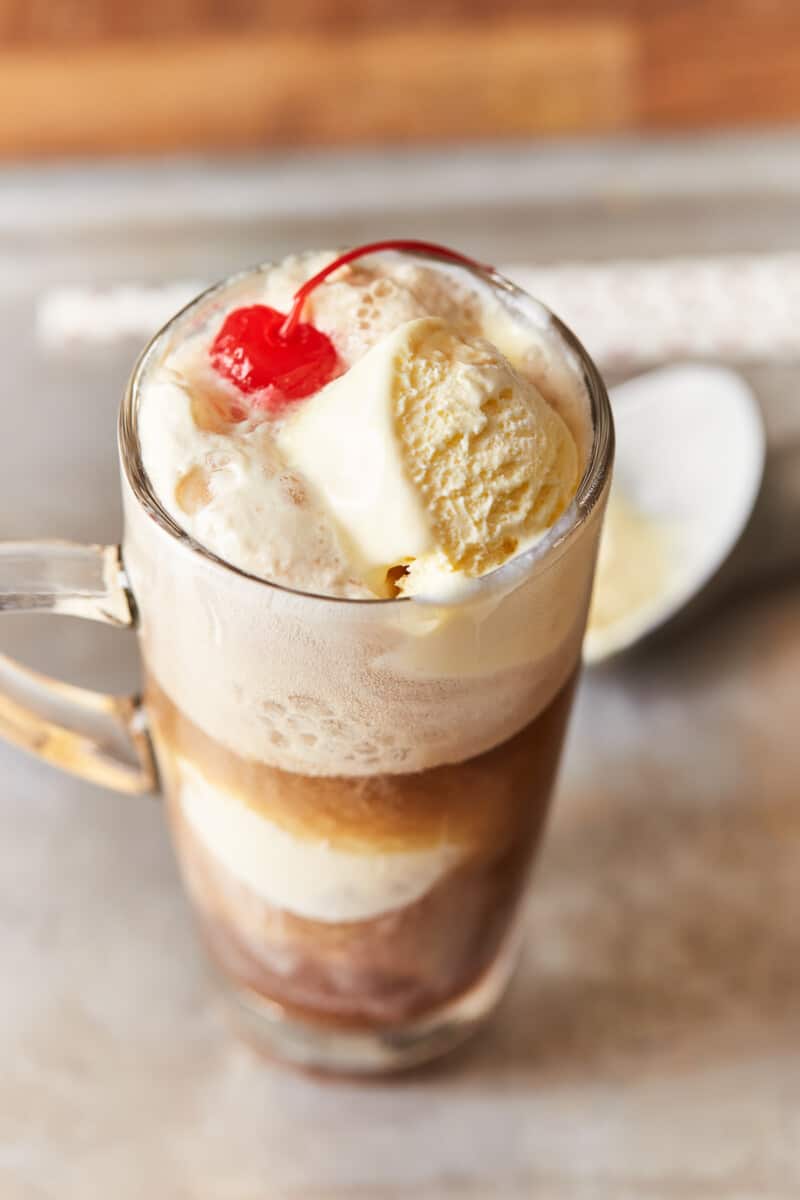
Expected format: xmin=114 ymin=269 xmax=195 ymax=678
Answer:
xmin=118 ymin=251 xmax=614 ymax=608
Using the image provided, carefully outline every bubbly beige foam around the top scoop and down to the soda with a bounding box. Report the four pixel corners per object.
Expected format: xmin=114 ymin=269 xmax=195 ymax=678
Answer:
xmin=125 ymin=256 xmax=599 ymax=775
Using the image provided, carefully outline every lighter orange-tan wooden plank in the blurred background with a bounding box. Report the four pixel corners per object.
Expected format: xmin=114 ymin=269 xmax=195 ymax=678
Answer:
xmin=0 ymin=18 xmax=636 ymax=155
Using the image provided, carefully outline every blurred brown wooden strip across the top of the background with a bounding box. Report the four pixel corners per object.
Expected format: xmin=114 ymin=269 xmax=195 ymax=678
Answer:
xmin=0 ymin=0 xmax=800 ymax=157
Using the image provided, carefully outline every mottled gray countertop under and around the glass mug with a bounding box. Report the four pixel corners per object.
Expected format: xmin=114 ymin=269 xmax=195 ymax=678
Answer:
xmin=0 ymin=137 xmax=800 ymax=1200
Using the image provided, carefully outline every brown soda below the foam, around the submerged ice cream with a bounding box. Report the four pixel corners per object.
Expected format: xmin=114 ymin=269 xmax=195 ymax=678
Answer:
xmin=149 ymin=679 xmax=575 ymax=1027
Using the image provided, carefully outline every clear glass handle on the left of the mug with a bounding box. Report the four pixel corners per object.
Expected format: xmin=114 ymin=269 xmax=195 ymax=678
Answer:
xmin=0 ymin=541 xmax=157 ymax=792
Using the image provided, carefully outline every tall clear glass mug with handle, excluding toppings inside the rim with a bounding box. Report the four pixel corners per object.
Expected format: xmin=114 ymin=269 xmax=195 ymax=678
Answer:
xmin=0 ymin=258 xmax=613 ymax=1072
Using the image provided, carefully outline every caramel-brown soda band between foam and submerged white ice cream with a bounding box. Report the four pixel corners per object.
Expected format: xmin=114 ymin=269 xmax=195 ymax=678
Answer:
xmin=146 ymin=676 xmax=573 ymax=857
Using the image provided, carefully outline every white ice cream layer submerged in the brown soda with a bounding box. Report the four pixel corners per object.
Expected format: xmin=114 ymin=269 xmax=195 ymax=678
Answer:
xmin=179 ymin=760 xmax=461 ymax=923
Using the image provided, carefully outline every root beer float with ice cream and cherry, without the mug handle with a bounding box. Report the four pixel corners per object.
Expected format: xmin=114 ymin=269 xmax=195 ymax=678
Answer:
xmin=125 ymin=242 xmax=604 ymax=1070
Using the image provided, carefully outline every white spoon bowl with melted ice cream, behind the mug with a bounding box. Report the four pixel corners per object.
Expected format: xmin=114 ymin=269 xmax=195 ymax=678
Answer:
xmin=584 ymin=364 xmax=766 ymax=664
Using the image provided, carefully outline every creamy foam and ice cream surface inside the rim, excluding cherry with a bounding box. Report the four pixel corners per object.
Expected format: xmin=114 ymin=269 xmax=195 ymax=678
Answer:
xmin=138 ymin=256 xmax=585 ymax=598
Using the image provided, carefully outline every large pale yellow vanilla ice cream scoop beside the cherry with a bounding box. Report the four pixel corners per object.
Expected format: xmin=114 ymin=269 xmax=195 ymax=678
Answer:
xmin=278 ymin=318 xmax=578 ymax=595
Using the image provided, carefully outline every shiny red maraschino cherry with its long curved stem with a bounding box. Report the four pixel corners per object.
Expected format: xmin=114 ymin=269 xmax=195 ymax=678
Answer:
xmin=210 ymin=240 xmax=486 ymax=412
